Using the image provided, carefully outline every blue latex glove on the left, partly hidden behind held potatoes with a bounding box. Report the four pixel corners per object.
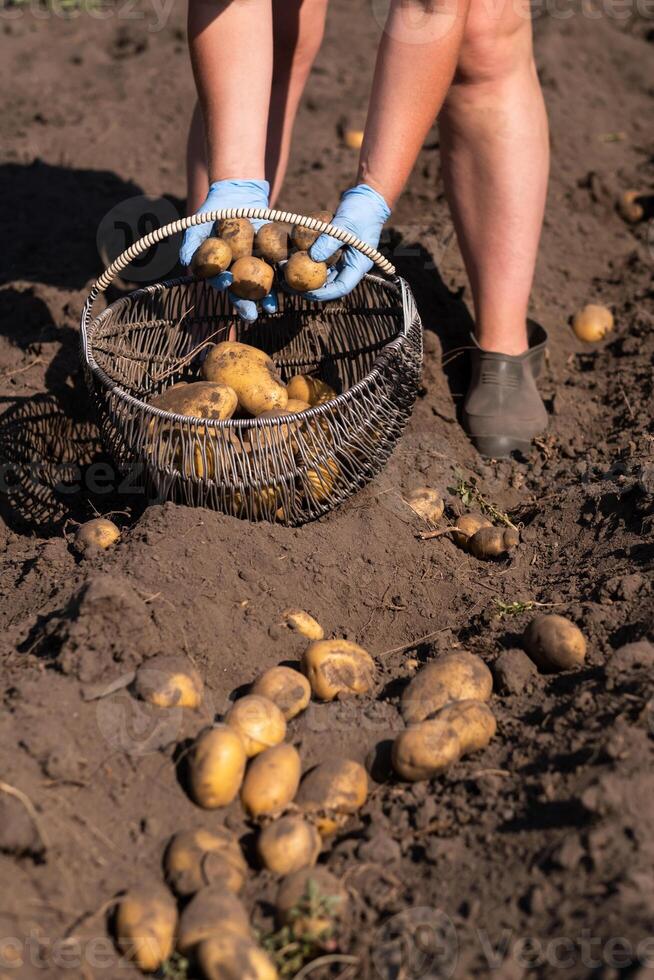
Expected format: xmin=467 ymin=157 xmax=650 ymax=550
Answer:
xmin=179 ymin=180 xmax=277 ymax=323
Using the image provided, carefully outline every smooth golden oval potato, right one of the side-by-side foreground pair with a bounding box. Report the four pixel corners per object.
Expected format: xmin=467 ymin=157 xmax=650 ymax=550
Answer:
xmin=241 ymin=744 xmax=302 ymax=819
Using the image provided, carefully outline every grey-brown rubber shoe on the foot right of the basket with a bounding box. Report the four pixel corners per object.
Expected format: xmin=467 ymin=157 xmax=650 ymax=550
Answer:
xmin=463 ymin=320 xmax=547 ymax=459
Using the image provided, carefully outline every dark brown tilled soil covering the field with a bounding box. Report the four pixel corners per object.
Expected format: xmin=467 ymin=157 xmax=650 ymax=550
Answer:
xmin=0 ymin=0 xmax=654 ymax=980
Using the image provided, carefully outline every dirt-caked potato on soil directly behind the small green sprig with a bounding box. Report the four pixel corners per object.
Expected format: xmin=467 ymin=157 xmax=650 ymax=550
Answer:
xmin=275 ymin=867 xmax=348 ymax=941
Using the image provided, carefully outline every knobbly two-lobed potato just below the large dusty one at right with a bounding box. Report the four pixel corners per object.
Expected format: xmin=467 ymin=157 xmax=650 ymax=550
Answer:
xmin=392 ymin=701 xmax=496 ymax=782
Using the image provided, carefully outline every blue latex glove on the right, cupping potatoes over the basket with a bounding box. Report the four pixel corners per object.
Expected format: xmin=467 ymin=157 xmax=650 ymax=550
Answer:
xmin=302 ymin=184 xmax=391 ymax=302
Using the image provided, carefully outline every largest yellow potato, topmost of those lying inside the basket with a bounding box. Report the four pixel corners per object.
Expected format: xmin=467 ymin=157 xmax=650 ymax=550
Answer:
xmin=202 ymin=341 xmax=288 ymax=415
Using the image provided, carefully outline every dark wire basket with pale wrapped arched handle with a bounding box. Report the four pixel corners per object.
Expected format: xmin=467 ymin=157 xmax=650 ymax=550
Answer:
xmin=81 ymin=208 xmax=422 ymax=525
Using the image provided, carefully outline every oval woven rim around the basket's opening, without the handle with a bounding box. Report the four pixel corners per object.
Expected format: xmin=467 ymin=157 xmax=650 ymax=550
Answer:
xmin=83 ymin=273 xmax=408 ymax=431
